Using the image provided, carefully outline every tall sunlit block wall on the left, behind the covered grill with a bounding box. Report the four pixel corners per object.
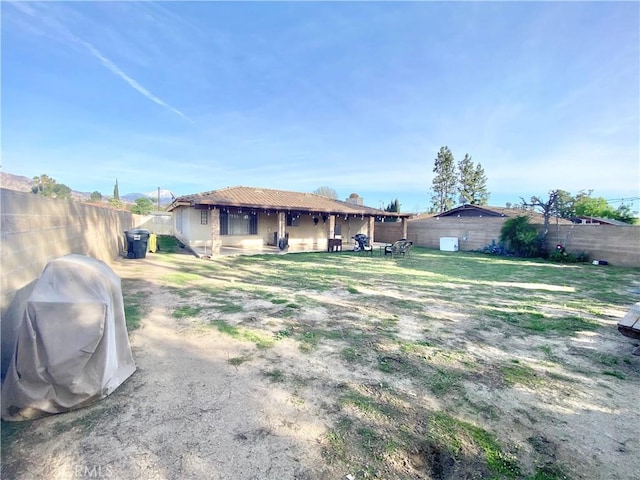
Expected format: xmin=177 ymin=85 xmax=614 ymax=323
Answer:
xmin=0 ymin=188 xmax=137 ymax=373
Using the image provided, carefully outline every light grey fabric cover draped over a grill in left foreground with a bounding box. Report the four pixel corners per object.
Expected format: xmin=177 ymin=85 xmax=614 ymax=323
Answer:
xmin=2 ymin=254 xmax=136 ymax=420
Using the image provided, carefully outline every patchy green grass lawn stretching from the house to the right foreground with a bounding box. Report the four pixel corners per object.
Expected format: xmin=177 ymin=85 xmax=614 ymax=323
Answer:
xmin=145 ymin=248 xmax=640 ymax=479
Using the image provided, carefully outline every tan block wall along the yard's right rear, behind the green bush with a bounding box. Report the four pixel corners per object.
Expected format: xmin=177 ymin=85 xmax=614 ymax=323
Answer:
xmin=375 ymin=217 xmax=640 ymax=267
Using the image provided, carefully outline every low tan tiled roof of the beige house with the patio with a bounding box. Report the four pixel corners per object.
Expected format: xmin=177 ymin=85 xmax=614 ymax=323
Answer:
xmin=169 ymin=186 xmax=410 ymax=217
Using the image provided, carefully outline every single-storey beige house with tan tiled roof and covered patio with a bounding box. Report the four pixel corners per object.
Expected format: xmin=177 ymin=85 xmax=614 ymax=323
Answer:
xmin=168 ymin=186 xmax=410 ymax=255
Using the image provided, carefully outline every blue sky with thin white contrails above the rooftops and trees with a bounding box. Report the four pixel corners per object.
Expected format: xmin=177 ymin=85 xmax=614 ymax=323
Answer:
xmin=1 ymin=2 xmax=640 ymax=212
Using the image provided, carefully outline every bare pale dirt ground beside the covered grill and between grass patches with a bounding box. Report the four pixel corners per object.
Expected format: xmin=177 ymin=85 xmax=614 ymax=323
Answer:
xmin=2 ymin=251 xmax=640 ymax=480
